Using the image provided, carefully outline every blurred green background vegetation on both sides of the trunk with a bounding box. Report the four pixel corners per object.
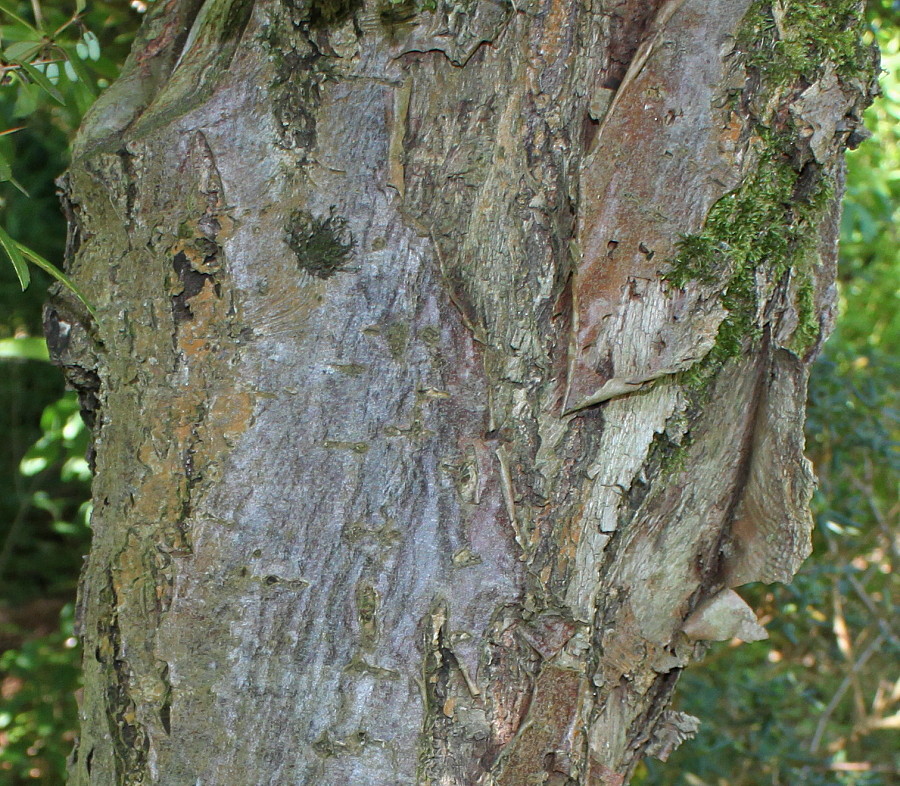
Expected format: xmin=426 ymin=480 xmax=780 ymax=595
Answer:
xmin=0 ymin=0 xmax=900 ymax=786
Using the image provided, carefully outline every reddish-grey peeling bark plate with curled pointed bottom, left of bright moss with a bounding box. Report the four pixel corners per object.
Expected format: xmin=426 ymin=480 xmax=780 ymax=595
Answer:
xmin=565 ymin=0 xmax=750 ymax=411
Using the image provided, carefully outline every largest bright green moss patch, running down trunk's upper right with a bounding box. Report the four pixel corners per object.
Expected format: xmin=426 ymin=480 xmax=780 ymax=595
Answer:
xmin=667 ymin=0 xmax=871 ymax=390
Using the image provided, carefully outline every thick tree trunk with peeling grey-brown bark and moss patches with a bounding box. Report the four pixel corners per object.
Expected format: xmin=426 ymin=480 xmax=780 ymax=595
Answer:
xmin=47 ymin=0 xmax=872 ymax=786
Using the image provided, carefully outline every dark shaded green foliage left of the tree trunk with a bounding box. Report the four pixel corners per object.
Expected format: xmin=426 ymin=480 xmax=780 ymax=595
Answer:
xmin=0 ymin=0 xmax=140 ymax=786
